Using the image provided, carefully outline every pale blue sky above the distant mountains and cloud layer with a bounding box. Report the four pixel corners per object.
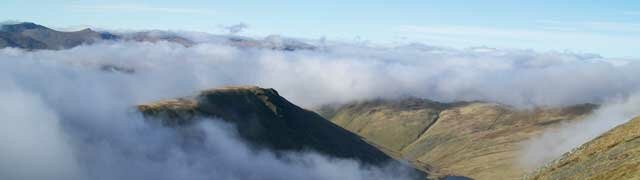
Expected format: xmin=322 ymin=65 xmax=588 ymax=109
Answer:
xmin=0 ymin=0 xmax=640 ymax=58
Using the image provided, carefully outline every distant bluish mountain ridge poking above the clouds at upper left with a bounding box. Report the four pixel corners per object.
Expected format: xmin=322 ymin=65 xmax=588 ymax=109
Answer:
xmin=0 ymin=22 xmax=317 ymax=51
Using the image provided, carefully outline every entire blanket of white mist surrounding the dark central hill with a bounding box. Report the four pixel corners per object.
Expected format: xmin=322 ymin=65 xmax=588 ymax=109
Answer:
xmin=0 ymin=33 xmax=640 ymax=179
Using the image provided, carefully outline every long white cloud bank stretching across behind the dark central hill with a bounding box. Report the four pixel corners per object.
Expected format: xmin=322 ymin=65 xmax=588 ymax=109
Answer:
xmin=0 ymin=38 xmax=640 ymax=107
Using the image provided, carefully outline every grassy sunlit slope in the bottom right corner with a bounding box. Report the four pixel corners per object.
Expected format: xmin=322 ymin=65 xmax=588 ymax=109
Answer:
xmin=525 ymin=117 xmax=640 ymax=180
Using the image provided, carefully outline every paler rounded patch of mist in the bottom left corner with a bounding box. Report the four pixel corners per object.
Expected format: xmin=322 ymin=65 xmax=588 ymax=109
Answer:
xmin=0 ymin=80 xmax=82 ymax=180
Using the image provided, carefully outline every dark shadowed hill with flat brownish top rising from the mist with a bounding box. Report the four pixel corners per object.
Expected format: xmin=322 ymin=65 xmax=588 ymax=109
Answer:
xmin=138 ymin=87 xmax=420 ymax=177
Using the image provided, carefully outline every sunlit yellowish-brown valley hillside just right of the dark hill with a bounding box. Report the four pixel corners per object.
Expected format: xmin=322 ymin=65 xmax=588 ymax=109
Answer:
xmin=319 ymin=99 xmax=595 ymax=179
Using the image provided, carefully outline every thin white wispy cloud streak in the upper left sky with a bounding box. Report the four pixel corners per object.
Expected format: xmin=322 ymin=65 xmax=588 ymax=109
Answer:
xmin=69 ymin=4 xmax=215 ymax=15
